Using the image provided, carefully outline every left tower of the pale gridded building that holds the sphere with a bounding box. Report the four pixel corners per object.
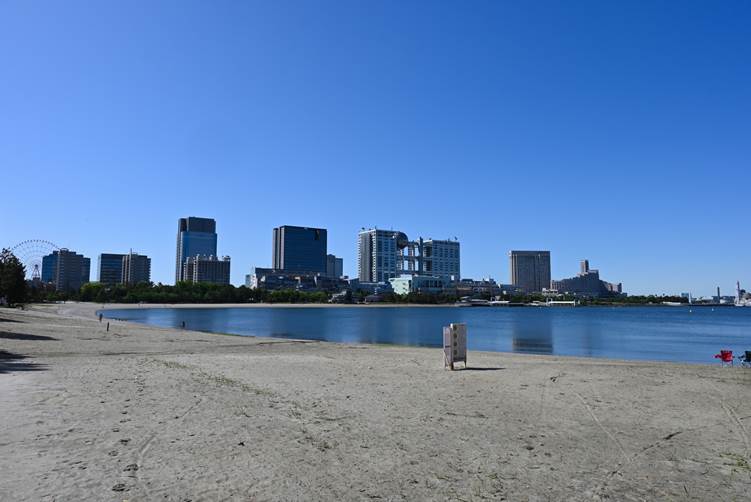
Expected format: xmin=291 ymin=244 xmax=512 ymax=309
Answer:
xmin=357 ymin=228 xmax=408 ymax=282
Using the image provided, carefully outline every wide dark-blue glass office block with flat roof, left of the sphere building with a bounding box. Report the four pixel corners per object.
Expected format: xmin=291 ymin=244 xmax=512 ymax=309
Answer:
xmin=271 ymin=225 xmax=327 ymax=275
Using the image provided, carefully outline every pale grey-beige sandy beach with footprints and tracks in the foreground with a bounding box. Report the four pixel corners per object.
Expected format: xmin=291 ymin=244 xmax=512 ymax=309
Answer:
xmin=0 ymin=304 xmax=751 ymax=501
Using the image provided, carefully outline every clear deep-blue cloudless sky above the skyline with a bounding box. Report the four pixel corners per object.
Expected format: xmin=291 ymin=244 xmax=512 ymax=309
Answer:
xmin=0 ymin=0 xmax=751 ymax=295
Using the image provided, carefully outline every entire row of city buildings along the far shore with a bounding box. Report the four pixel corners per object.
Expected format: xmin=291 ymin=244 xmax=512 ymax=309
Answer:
xmin=33 ymin=216 xmax=623 ymax=297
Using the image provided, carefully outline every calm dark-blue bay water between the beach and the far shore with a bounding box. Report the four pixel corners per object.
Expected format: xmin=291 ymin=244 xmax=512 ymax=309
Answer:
xmin=102 ymin=307 xmax=751 ymax=363
